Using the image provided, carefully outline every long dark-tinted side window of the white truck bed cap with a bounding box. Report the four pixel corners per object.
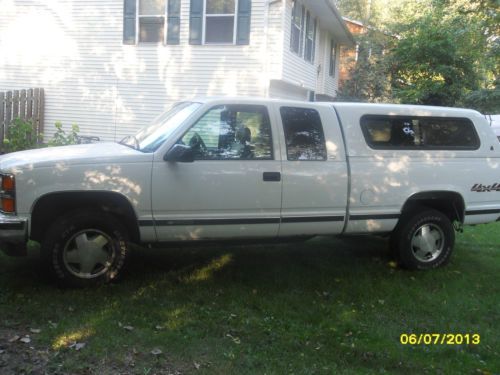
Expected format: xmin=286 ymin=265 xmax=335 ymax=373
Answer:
xmin=361 ymin=115 xmax=480 ymax=150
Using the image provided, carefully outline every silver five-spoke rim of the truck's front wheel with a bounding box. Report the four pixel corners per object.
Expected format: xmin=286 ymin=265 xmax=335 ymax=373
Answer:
xmin=63 ymin=229 xmax=115 ymax=279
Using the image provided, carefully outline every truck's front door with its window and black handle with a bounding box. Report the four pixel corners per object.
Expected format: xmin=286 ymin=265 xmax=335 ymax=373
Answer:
xmin=152 ymin=104 xmax=281 ymax=241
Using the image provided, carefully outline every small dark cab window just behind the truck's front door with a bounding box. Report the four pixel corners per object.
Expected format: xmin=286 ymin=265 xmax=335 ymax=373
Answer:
xmin=280 ymin=107 xmax=326 ymax=161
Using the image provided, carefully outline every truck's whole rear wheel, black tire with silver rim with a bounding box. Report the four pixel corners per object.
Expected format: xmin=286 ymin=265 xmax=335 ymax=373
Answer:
xmin=390 ymin=208 xmax=455 ymax=270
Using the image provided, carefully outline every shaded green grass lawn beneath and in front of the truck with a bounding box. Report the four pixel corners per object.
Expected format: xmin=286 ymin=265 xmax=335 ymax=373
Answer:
xmin=0 ymin=223 xmax=500 ymax=375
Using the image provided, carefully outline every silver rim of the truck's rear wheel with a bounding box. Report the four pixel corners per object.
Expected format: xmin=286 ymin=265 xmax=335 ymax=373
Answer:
xmin=411 ymin=223 xmax=445 ymax=262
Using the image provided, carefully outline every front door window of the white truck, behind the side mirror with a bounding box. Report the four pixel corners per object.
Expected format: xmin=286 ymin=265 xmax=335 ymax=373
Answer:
xmin=178 ymin=105 xmax=273 ymax=160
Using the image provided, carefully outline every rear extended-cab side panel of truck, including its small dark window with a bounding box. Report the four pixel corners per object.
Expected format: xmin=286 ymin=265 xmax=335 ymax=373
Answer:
xmin=277 ymin=105 xmax=348 ymax=237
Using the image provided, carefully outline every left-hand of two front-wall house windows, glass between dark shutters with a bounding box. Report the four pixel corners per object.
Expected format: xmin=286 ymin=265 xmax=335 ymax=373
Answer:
xmin=138 ymin=0 xmax=166 ymax=43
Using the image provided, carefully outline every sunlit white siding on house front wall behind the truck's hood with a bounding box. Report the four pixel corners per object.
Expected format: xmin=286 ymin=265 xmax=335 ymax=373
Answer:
xmin=0 ymin=0 xmax=275 ymax=140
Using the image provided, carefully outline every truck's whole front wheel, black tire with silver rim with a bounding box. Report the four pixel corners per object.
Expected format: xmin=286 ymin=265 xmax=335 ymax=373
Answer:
xmin=41 ymin=210 xmax=129 ymax=287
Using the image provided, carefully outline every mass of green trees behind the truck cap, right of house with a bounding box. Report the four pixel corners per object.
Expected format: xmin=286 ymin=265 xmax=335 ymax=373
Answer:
xmin=337 ymin=0 xmax=500 ymax=111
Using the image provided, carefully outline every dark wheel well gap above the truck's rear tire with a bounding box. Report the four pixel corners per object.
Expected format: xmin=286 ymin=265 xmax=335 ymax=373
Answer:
xmin=401 ymin=191 xmax=465 ymax=223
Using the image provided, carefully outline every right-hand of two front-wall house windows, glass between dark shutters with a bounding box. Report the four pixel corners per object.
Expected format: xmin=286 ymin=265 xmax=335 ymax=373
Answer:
xmin=205 ymin=0 xmax=236 ymax=44
